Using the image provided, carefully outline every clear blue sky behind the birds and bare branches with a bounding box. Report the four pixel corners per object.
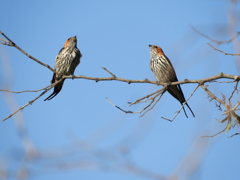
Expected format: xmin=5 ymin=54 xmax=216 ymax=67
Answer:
xmin=0 ymin=0 xmax=240 ymax=180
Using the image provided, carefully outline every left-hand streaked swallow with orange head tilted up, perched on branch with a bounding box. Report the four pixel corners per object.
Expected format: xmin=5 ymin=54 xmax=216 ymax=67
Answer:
xmin=44 ymin=36 xmax=82 ymax=101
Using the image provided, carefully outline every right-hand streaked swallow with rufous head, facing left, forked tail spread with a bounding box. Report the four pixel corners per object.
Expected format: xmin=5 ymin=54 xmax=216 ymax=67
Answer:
xmin=149 ymin=44 xmax=195 ymax=118
